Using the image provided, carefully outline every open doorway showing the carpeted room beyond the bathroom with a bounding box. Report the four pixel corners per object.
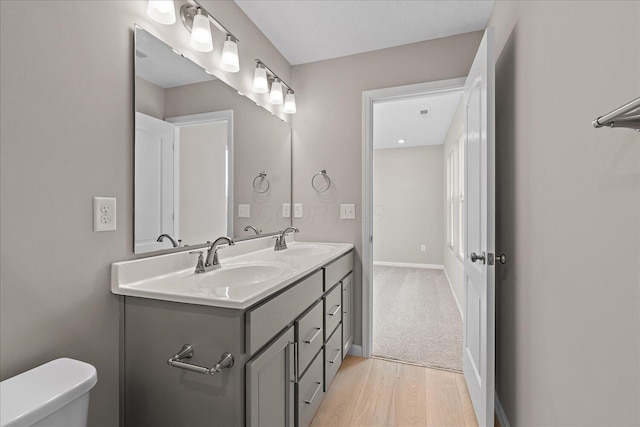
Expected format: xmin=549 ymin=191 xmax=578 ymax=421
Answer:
xmin=364 ymin=84 xmax=463 ymax=372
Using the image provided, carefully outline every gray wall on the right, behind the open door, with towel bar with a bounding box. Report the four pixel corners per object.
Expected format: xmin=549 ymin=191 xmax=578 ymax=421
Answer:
xmin=490 ymin=1 xmax=640 ymax=426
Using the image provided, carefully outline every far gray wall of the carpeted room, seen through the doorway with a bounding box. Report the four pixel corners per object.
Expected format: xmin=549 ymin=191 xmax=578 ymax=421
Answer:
xmin=373 ymin=145 xmax=445 ymax=265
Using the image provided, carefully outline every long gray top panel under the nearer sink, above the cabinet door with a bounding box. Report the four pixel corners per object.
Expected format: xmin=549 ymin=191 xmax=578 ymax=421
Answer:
xmin=245 ymin=271 xmax=322 ymax=355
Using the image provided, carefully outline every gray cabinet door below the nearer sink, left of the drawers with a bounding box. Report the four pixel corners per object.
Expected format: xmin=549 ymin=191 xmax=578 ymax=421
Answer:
xmin=246 ymin=327 xmax=295 ymax=427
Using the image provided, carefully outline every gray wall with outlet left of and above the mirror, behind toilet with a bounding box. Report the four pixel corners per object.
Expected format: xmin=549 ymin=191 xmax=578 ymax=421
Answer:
xmin=0 ymin=1 xmax=289 ymax=426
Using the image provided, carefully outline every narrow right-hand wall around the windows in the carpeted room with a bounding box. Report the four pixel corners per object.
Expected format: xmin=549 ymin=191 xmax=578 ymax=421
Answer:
xmin=441 ymin=99 xmax=464 ymax=314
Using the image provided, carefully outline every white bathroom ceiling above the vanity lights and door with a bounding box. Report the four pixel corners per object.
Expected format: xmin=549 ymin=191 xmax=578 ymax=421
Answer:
xmin=235 ymin=0 xmax=493 ymax=65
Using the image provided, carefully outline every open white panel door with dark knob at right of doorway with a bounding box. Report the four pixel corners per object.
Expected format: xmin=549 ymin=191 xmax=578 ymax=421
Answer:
xmin=463 ymin=28 xmax=495 ymax=427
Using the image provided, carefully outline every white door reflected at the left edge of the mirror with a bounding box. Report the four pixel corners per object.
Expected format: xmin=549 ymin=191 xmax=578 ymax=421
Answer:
xmin=134 ymin=112 xmax=178 ymax=253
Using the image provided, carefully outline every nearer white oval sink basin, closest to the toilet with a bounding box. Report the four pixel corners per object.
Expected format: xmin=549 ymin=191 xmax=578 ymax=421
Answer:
xmin=195 ymin=263 xmax=287 ymax=288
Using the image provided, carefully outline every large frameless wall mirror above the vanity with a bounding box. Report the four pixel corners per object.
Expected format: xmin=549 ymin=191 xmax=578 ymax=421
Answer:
xmin=134 ymin=26 xmax=291 ymax=253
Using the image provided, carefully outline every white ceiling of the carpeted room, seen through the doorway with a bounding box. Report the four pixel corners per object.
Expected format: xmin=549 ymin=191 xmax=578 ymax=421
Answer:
xmin=373 ymin=91 xmax=462 ymax=149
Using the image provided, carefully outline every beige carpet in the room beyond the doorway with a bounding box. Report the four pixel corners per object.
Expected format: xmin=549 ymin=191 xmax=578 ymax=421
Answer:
xmin=373 ymin=266 xmax=462 ymax=372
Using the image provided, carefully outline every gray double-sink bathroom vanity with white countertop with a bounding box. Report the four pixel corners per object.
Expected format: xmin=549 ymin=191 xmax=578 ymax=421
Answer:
xmin=112 ymin=238 xmax=353 ymax=426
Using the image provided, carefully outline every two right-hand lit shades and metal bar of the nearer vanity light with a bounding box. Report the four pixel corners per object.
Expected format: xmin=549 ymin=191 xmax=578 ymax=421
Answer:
xmin=180 ymin=0 xmax=240 ymax=73
